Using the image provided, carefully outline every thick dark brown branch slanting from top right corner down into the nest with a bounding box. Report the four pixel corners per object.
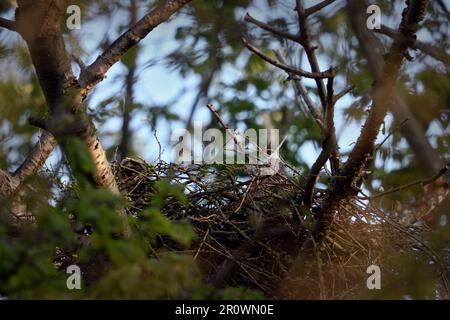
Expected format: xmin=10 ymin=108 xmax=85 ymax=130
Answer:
xmin=291 ymin=0 xmax=428 ymax=277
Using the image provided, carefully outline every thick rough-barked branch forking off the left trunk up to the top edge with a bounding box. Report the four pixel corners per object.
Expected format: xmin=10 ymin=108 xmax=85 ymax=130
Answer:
xmin=79 ymin=0 xmax=192 ymax=89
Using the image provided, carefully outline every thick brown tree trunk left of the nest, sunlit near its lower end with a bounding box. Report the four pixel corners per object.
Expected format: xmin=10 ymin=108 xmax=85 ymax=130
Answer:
xmin=16 ymin=0 xmax=119 ymax=194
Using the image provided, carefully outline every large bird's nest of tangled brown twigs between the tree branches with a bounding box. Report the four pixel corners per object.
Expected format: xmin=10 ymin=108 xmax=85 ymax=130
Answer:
xmin=114 ymin=158 xmax=440 ymax=299
